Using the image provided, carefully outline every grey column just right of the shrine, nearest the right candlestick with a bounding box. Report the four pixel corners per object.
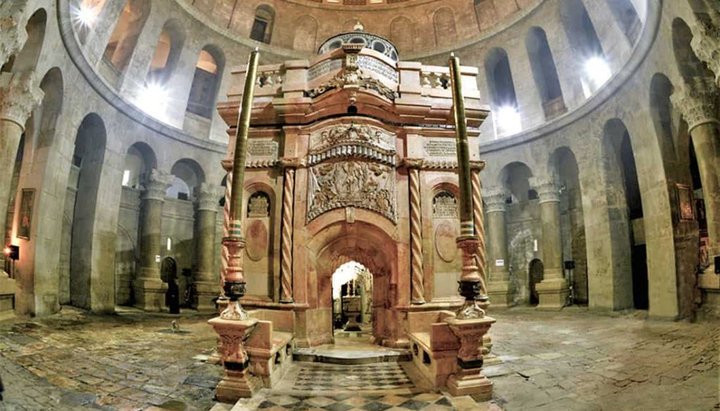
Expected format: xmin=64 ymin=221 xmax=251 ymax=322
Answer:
xmin=483 ymin=187 xmax=512 ymax=307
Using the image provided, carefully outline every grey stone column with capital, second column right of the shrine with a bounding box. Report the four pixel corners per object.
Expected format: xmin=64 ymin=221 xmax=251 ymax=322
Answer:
xmin=530 ymin=177 xmax=569 ymax=309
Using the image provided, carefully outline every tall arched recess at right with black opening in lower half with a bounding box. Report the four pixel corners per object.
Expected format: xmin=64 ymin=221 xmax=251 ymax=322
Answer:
xmin=602 ymin=119 xmax=649 ymax=309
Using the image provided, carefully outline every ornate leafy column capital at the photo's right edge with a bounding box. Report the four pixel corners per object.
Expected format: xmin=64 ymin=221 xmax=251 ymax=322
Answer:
xmin=670 ymin=77 xmax=718 ymax=130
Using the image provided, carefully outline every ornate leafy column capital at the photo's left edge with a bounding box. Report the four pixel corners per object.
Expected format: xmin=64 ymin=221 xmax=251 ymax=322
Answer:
xmin=0 ymin=71 xmax=45 ymax=130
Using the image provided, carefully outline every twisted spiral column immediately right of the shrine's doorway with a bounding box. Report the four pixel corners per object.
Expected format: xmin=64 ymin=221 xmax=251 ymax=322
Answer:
xmin=405 ymin=159 xmax=425 ymax=304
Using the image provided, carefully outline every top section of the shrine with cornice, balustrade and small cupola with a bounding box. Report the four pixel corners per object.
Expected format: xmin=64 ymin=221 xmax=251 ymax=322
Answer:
xmin=218 ymin=30 xmax=489 ymax=130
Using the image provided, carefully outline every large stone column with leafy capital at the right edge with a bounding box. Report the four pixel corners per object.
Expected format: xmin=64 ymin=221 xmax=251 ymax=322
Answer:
xmin=670 ymin=77 xmax=720 ymax=260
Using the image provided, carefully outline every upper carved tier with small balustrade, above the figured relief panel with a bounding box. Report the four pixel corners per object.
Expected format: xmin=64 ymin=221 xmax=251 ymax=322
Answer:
xmin=309 ymin=124 xmax=396 ymax=165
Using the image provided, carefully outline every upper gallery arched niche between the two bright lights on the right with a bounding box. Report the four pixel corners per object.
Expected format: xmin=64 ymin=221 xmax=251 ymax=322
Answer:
xmin=525 ymin=27 xmax=567 ymax=119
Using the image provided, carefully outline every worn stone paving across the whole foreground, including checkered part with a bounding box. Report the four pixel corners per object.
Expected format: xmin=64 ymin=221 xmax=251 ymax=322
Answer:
xmin=0 ymin=307 xmax=720 ymax=411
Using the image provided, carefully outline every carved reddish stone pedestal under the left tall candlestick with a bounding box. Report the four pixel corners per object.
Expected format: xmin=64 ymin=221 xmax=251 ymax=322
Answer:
xmin=208 ymin=317 xmax=260 ymax=403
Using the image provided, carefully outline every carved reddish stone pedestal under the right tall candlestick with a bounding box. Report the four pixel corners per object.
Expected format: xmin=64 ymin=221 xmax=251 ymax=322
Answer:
xmin=445 ymin=317 xmax=495 ymax=401
